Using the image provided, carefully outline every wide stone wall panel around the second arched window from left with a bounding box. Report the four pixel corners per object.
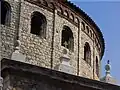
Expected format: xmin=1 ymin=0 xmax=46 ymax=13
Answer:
xmin=20 ymin=2 xmax=53 ymax=68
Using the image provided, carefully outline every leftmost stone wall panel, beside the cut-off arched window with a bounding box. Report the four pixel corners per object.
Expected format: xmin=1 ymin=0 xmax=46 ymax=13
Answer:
xmin=0 ymin=0 xmax=19 ymax=58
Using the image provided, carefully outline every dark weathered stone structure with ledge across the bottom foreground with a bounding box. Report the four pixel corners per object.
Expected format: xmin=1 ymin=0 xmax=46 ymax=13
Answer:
xmin=2 ymin=59 xmax=120 ymax=90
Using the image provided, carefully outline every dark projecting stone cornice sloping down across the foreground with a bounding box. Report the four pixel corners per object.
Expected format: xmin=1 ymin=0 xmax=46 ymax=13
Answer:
xmin=1 ymin=58 xmax=120 ymax=90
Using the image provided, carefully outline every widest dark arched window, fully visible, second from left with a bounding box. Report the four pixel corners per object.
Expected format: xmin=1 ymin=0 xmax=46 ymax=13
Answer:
xmin=31 ymin=11 xmax=47 ymax=38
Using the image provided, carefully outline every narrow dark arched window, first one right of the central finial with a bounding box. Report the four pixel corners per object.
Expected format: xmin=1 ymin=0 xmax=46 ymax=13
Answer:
xmin=84 ymin=42 xmax=91 ymax=65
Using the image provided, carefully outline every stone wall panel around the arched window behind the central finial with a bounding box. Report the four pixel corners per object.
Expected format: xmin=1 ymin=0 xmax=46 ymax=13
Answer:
xmin=53 ymin=15 xmax=78 ymax=74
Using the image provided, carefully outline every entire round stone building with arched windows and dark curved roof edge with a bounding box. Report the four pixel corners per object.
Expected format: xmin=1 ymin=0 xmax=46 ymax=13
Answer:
xmin=0 ymin=0 xmax=104 ymax=80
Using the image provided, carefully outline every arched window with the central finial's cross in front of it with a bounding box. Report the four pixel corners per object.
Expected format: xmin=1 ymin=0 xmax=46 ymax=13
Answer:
xmin=62 ymin=26 xmax=74 ymax=51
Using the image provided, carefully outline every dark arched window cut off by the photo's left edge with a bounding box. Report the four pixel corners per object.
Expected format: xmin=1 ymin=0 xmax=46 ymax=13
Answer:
xmin=0 ymin=1 xmax=11 ymax=26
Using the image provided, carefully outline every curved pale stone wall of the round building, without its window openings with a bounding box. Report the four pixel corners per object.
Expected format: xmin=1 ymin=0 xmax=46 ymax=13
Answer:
xmin=0 ymin=0 xmax=102 ymax=79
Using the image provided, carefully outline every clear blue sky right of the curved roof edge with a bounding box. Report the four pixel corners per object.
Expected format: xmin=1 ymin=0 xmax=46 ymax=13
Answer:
xmin=70 ymin=0 xmax=120 ymax=83
